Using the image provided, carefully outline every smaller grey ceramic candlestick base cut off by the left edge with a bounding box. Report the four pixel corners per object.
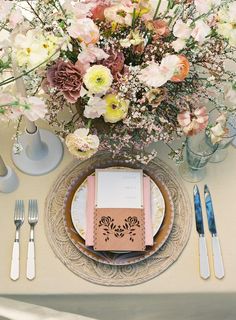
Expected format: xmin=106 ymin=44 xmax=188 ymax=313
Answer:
xmin=0 ymin=156 xmax=19 ymax=193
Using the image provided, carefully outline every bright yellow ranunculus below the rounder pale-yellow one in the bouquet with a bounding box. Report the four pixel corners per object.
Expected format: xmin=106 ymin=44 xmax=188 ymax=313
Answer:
xmin=103 ymin=94 xmax=129 ymax=123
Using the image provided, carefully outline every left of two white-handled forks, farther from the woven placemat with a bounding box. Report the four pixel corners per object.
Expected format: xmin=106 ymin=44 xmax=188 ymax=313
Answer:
xmin=10 ymin=200 xmax=25 ymax=280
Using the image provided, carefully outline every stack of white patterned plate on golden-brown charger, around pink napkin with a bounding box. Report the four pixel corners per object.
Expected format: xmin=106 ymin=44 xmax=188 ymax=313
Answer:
xmin=63 ymin=167 xmax=174 ymax=265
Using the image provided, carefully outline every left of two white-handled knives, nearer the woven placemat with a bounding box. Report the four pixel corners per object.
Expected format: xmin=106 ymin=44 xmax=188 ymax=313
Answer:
xmin=193 ymin=185 xmax=210 ymax=279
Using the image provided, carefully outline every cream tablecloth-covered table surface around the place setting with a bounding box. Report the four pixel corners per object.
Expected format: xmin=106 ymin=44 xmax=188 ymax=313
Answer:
xmin=0 ymin=123 xmax=236 ymax=294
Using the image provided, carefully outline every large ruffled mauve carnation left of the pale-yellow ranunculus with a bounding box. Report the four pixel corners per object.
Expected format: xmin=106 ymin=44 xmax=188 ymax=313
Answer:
xmin=47 ymin=60 xmax=82 ymax=103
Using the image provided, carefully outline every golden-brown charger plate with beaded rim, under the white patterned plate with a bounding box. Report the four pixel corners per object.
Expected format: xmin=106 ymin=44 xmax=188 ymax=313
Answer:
xmin=63 ymin=165 xmax=174 ymax=265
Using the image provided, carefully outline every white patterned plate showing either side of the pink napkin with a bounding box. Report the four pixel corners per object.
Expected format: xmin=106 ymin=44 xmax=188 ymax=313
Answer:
xmin=71 ymin=174 xmax=165 ymax=239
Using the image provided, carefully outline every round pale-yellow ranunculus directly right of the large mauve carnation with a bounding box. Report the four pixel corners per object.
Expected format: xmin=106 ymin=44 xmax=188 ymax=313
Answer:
xmin=83 ymin=65 xmax=113 ymax=94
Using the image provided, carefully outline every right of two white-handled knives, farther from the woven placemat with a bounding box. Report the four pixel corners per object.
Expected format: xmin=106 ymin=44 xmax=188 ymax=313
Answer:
xmin=204 ymin=185 xmax=225 ymax=279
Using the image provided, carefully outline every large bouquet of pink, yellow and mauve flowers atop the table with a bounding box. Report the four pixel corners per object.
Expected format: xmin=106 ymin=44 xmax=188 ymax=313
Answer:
xmin=0 ymin=0 xmax=236 ymax=162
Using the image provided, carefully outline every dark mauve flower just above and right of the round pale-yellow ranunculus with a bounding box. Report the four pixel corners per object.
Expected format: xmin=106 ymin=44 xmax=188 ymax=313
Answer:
xmin=102 ymin=51 xmax=125 ymax=79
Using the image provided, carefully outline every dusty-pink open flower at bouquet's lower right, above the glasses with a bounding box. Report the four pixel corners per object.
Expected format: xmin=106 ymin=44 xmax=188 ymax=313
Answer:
xmin=177 ymin=107 xmax=209 ymax=136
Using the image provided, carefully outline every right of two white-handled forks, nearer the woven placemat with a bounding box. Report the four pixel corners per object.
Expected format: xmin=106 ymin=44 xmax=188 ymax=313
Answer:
xmin=26 ymin=200 xmax=38 ymax=280
